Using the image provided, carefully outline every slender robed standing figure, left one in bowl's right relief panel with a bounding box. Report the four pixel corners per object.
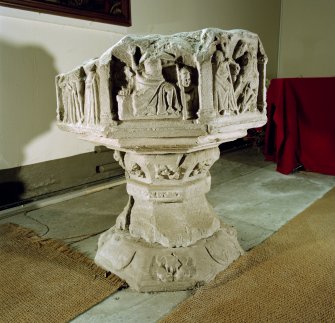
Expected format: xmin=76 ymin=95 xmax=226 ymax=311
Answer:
xmin=213 ymin=50 xmax=238 ymax=115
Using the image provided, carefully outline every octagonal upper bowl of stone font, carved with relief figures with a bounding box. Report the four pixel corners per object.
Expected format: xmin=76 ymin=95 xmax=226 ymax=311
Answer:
xmin=56 ymin=28 xmax=267 ymax=138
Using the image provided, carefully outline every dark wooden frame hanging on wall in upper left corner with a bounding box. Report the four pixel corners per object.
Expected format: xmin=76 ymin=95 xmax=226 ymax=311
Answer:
xmin=0 ymin=0 xmax=131 ymax=26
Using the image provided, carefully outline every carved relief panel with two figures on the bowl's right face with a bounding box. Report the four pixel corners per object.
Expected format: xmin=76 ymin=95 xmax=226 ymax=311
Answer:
xmin=212 ymin=35 xmax=265 ymax=115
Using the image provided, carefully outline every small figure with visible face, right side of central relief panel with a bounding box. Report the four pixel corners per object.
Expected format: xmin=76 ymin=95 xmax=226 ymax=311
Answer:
xmin=179 ymin=67 xmax=199 ymax=119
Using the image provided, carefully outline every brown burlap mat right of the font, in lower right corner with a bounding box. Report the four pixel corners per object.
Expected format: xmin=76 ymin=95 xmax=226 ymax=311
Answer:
xmin=161 ymin=189 xmax=335 ymax=323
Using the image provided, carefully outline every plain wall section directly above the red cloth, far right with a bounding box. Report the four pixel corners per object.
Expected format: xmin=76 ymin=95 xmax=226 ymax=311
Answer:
xmin=278 ymin=0 xmax=335 ymax=77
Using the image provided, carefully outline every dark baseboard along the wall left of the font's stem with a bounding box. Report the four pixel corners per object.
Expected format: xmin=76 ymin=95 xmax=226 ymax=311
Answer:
xmin=0 ymin=146 xmax=124 ymax=210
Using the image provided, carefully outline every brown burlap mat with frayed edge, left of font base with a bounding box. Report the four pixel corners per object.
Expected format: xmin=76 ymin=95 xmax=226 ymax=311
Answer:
xmin=0 ymin=224 xmax=124 ymax=323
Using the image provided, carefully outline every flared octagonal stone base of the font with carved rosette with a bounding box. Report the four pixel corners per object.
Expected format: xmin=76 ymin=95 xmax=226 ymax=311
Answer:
xmin=95 ymin=224 xmax=243 ymax=292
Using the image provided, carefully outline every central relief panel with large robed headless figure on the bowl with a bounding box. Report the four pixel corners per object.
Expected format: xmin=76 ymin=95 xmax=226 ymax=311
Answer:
xmin=114 ymin=47 xmax=199 ymax=120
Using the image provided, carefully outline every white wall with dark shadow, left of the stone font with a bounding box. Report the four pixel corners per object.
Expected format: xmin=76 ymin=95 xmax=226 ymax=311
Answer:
xmin=0 ymin=12 xmax=122 ymax=168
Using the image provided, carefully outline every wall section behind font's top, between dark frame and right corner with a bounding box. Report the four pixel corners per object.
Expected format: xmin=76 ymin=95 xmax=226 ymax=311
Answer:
xmin=129 ymin=0 xmax=281 ymax=78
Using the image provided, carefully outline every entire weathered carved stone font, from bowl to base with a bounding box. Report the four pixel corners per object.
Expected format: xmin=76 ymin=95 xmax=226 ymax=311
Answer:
xmin=56 ymin=29 xmax=267 ymax=291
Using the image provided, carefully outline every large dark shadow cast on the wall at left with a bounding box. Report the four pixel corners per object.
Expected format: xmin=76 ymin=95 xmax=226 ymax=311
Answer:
xmin=0 ymin=40 xmax=57 ymax=208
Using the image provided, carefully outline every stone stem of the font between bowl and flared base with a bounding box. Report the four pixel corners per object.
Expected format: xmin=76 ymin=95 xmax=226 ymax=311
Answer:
xmin=116 ymin=148 xmax=220 ymax=247
